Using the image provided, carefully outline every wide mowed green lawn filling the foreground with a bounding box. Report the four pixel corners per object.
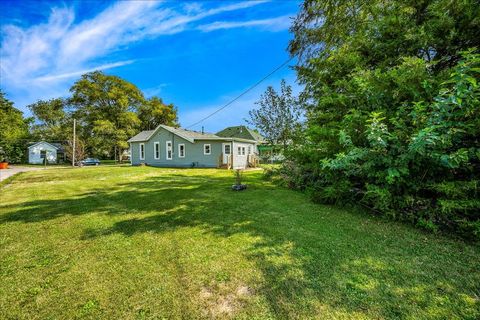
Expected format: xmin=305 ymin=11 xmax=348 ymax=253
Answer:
xmin=0 ymin=167 xmax=480 ymax=319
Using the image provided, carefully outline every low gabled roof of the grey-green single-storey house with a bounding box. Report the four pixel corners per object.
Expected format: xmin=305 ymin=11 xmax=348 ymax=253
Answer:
xmin=128 ymin=124 xmax=253 ymax=143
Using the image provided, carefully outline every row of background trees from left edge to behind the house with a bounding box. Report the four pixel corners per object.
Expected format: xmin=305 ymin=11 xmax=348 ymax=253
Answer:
xmin=0 ymin=71 xmax=178 ymax=162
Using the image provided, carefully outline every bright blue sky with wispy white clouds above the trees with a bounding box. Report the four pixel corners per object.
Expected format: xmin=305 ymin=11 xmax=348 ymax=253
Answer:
xmin=0 ymin=0 xmax=300 ymax=132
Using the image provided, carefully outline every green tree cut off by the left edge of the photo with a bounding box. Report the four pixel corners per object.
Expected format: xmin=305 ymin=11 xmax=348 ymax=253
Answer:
xmin=0 ymin=90 xmax=31 ymax=163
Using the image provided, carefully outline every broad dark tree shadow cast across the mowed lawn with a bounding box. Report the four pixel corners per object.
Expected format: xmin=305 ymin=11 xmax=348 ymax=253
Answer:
xmin=0 ymin=173 xmax=480 ymax=318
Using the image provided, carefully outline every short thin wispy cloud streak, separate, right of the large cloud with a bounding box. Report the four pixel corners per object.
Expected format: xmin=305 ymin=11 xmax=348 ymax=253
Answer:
xmin=198 ymin=16 xmax=291 ymax=32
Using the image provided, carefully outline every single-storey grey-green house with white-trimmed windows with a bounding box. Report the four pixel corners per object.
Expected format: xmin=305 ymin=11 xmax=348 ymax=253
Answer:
xmin=128 ymin=125 xmax=257 ymax=169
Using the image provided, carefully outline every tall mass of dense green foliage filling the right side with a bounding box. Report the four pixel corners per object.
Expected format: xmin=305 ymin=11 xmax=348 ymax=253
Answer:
xmin=284 ymin=0 xmax=480 ymax=238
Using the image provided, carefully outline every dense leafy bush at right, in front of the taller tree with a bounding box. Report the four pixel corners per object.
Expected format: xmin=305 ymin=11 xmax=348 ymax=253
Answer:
xmin=284 ymin=51 xmax=480 ymax=240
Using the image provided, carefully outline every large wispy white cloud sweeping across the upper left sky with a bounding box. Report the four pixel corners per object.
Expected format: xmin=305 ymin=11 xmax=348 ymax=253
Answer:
xmin=0 ymin=1 xmax=274 ymax=102
